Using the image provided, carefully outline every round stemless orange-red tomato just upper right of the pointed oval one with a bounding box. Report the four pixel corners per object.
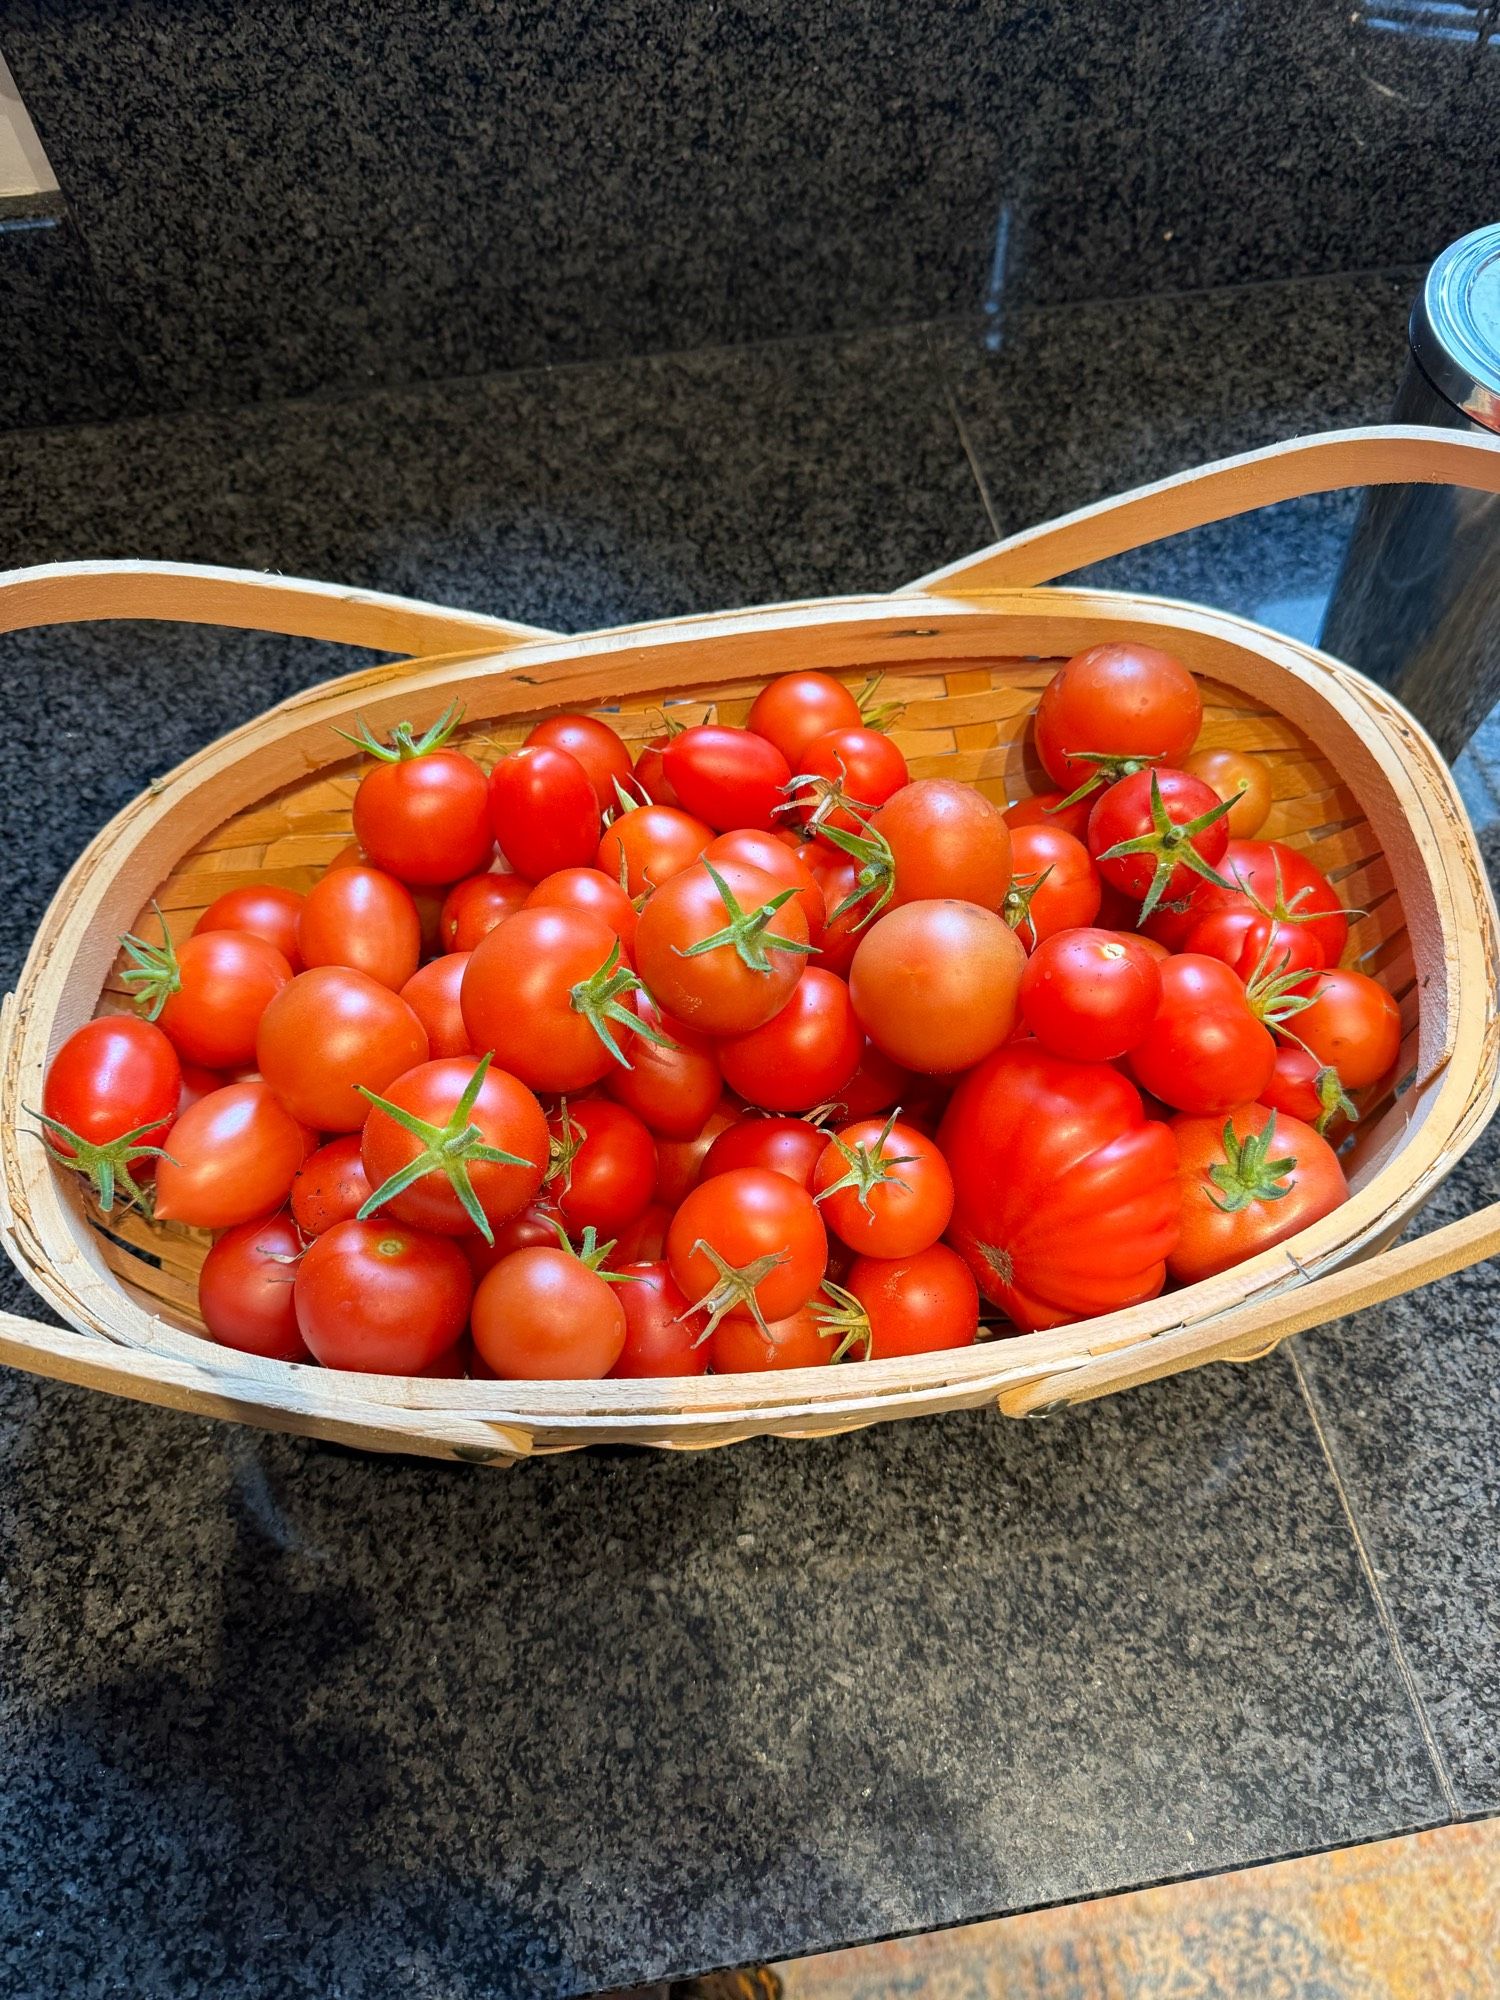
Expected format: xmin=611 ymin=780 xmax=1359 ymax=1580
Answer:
xmin=256 ymin=966 xmax=428 ymax=1132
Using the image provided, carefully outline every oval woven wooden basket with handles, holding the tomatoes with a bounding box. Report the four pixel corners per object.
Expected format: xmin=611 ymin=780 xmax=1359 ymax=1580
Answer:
xmin=0 ymin=430 xmax=1500 ymax=1464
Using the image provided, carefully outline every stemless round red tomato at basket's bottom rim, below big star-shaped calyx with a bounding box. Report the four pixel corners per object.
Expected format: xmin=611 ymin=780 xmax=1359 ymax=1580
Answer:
xmin=294 ymin=1216 xmax=474 ymax=1374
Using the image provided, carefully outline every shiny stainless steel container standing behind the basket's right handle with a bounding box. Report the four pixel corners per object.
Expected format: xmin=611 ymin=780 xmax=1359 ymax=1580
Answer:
xmin=1322 ymin=222 xmax=1500 ymax=758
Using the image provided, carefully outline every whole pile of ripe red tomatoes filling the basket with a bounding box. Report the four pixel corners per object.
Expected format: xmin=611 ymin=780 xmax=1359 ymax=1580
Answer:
xmin=40 ymin=644 xmax=1400 ymax=1380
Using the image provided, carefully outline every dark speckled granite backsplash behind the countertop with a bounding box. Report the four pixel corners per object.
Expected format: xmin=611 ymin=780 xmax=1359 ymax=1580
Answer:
xmin=0 ymin=0 xmax=1500 ymax=426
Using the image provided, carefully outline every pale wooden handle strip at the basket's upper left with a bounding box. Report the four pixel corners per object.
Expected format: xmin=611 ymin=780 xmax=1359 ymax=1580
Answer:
xmin=0 ymin=562 xmax=556 ymax=658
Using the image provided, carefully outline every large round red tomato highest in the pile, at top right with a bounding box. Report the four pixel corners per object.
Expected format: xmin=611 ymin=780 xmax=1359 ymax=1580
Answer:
xmin=1036 ymin=640 xmax=1204 ymax=792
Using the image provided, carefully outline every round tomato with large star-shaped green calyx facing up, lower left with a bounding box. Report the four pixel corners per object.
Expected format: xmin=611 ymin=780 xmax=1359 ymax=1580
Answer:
xmin=360 ymin=1056 xmax=548 ymax=1236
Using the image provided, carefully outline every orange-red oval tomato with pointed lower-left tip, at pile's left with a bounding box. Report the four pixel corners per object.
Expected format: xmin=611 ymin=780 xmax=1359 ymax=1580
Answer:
xmin=156 ymin=1084 xmax=316 ymax=1230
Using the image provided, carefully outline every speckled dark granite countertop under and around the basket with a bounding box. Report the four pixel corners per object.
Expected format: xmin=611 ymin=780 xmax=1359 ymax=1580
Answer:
xmin=0 ymin=274 xmax=1500 ymax=2000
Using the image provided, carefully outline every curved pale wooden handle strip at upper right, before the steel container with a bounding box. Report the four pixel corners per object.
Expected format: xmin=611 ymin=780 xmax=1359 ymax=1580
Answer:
xmin=906 ymin=424 xmax=1500 ymax=596
